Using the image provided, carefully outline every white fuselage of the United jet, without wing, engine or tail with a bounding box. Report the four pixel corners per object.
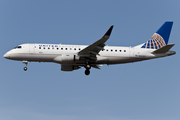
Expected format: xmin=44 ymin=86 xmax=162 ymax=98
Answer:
xmin=4 ymin=44 xmax=175 ymax=66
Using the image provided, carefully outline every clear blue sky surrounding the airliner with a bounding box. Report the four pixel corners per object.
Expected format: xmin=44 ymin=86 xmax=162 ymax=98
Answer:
xmin=0 ymin=0 xmax=180 ymax=120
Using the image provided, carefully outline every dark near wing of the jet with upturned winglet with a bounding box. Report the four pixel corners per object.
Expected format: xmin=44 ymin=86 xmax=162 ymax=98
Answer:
xmin=78 ymin=25 xmax=113 ymax=60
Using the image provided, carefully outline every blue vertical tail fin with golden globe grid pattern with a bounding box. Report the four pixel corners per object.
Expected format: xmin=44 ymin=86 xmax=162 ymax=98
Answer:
xmin=141 ymin=22 xmax=173 ymax=49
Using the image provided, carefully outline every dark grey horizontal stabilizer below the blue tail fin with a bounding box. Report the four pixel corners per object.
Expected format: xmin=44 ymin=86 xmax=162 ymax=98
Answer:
xmin=152 ymin=44 xmax=175 ymax=54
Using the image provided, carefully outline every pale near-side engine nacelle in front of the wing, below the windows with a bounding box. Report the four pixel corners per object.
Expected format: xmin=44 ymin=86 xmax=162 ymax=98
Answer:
xmin=54 ymin=54 xmax=79 ymax=64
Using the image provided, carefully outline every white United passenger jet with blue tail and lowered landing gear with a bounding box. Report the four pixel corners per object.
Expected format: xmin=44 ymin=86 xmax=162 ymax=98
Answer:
xmin=4 ymin=21 xmax=176 ymax=75
